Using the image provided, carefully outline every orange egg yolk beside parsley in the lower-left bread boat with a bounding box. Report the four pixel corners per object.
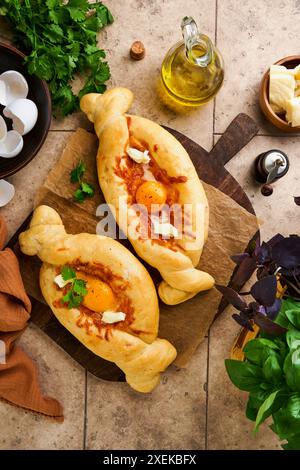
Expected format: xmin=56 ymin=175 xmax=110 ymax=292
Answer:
xmin=76 ymin=271 xmax=117 ymax=312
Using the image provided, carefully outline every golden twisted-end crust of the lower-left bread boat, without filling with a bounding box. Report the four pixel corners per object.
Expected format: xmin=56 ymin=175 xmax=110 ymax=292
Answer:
xmin=19 ymin=206 xmax=176 ymax=393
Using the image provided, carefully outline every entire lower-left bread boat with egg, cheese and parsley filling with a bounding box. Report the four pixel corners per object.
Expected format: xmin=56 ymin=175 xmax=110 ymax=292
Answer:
xmin=19 ymin=206 xmax=176 ymax=392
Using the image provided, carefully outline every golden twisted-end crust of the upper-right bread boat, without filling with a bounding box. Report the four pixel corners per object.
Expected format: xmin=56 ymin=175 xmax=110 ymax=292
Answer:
xmin=80 ymin=88 xmax=214 ymax=305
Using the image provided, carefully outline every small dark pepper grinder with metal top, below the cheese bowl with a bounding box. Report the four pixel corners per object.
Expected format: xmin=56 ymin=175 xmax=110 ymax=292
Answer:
xmin=255 ymin=149 xmax=290 ymax=196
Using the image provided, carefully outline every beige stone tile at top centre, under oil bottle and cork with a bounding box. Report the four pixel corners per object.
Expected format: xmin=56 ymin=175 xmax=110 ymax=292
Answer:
xmin=52 ymin=0 xmax=215 ymax=148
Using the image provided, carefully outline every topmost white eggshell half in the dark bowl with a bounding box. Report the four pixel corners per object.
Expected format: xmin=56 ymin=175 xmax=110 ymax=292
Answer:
xmin=0 ymin=70 xmax=28 ymax=106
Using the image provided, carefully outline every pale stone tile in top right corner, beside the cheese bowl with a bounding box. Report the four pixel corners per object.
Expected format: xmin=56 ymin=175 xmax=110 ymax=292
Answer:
xmin=215 ymin=0 xmax=300 ymax=134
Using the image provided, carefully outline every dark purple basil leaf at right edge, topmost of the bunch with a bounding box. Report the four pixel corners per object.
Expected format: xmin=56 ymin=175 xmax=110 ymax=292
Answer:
xmin=272 ymin=235 xmax=300 ymax=269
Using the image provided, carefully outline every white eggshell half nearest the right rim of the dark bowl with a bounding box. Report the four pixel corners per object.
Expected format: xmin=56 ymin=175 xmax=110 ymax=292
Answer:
xmin=3 ymin=98 xmax=38 ymax=135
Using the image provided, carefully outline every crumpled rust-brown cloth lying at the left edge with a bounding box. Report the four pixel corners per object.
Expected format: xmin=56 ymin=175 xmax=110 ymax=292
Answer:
xmin=0 ymin=216 xmax=64 ymax=422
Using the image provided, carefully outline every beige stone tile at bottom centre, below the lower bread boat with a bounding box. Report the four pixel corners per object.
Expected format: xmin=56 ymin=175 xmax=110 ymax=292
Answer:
xmin=86 ymin=340 xmax=207 ymax=450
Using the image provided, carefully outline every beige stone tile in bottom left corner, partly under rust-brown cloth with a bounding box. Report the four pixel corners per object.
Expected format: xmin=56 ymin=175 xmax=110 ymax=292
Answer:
xmin=0 ymin=326 xmax=85 ymax=450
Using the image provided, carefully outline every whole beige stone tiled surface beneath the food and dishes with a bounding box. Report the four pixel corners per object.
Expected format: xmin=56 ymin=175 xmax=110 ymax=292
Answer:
xmin=0 ymin=0 xmax=300 ymax=449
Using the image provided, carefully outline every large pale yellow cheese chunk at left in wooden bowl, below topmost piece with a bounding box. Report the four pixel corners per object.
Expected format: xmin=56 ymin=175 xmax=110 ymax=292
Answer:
xmin=269 ymin=72 xmax=296 ymax=113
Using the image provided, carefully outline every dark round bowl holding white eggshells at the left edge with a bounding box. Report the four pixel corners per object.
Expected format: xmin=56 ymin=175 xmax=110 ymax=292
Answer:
xmin=0 ymin=43 xmax=51 ymax=179
